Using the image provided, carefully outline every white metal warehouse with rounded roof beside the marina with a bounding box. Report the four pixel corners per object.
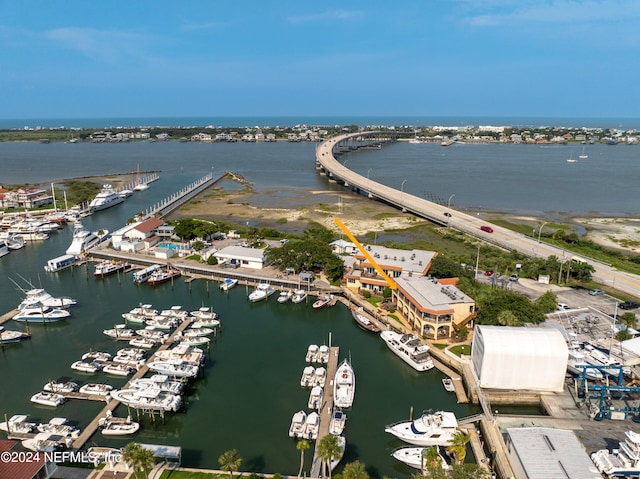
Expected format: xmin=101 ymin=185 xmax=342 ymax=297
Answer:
xmin=471 ymin=326 xmax=568 ymax=391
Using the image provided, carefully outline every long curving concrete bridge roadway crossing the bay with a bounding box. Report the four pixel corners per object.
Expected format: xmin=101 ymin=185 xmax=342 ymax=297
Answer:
xmin=316 ymin=131 xmax=640 ymax=298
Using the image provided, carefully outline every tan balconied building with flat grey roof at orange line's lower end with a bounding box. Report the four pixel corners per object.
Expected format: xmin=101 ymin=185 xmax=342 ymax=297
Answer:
xmin=393 ymin=275 xmax=476 ymax=339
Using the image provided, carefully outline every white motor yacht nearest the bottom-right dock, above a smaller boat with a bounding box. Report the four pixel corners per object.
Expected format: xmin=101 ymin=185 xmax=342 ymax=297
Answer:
xmin=384 ymin=411 xmax=458 ymax=446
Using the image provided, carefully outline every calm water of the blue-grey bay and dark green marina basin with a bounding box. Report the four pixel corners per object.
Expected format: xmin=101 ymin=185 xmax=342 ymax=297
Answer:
xmin=0 ymin=137 xmax=640 ymax=477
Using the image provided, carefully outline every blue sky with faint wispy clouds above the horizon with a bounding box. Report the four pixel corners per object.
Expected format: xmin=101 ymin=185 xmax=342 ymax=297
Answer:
xmin=0 ymin=0 xmax=640 ymax=118
